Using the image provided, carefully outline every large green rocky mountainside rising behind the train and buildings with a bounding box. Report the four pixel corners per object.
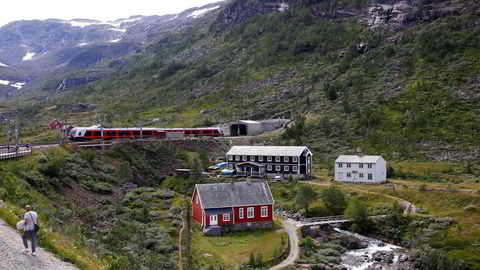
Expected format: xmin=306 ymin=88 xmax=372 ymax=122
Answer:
xmin=0 ymin=0 xmax=480 ymax=161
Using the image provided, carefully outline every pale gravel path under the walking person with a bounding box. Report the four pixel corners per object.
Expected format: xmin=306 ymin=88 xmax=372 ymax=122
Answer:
xmin=0 ymin=220 xmax=77 ymax=270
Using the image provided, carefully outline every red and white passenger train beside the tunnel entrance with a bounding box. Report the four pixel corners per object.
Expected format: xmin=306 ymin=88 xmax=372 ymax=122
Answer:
xmin=67 ymin=126 xmax=224 ymax=141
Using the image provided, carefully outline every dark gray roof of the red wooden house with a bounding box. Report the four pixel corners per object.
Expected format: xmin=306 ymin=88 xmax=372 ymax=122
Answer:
xmin=196 ymin=181 xmax=274 ymax=209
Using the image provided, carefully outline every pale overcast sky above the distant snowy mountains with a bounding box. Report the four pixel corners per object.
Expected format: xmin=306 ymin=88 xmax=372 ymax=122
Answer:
xmin=0 ymin=0 xmax=223 ymax=26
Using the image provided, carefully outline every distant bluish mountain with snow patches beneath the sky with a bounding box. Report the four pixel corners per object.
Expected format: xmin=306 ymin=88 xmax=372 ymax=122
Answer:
xmin=0 ymin=3 xmax=222 ymax=98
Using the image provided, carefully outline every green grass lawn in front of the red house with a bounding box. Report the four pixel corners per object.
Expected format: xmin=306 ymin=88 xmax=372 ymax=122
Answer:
xmin=192 ymin=220 xmax=288 ymax=269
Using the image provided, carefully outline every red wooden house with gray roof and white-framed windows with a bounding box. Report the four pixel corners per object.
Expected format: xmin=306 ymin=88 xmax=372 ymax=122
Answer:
xmin=192 ymin=180 xmax=275 ymax=234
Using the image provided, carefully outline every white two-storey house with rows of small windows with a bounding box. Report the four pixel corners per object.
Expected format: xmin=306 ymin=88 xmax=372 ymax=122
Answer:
xmin=335 ymin=155 xmax=387 ymax=184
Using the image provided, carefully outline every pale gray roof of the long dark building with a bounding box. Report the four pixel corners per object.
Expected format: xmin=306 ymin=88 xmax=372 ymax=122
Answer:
xmin=227 ymin=146 xmax=308 ymax=157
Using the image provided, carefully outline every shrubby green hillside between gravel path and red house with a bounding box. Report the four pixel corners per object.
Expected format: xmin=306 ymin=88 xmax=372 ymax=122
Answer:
xmin=0 ymin=143 xmax=204 ymax=270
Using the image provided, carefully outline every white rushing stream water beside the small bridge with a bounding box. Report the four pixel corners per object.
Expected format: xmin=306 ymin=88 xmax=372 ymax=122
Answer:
xmin=334 ymin=228 xmax=406 ymax=270
